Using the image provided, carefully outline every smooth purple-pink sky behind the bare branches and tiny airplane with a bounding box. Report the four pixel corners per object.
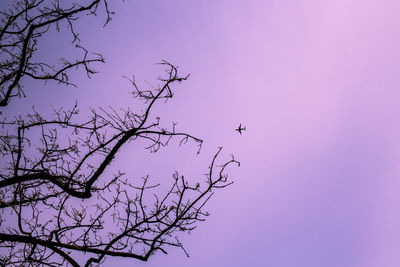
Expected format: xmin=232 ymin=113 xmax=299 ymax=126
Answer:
xmin=4 ymin=0 xmax=400 ymax=267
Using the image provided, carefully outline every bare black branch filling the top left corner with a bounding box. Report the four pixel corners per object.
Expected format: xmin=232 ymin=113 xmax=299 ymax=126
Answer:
xmin=0 ymin=0 xmax=113 ymax=107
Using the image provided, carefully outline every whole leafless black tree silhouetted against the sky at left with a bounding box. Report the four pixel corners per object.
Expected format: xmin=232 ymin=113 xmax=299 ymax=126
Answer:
xmin=0 ymin=0 xmax=239 ymax=266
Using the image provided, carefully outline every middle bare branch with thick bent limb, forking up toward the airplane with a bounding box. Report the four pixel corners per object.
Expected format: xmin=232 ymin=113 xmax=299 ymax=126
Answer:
xmin=0 ymin=62 xmax=202 ymax=198
